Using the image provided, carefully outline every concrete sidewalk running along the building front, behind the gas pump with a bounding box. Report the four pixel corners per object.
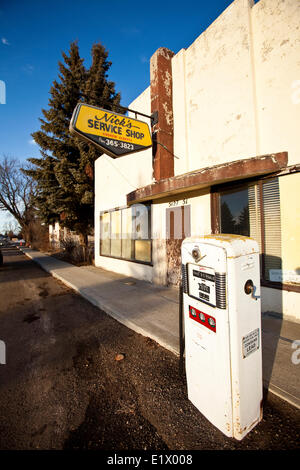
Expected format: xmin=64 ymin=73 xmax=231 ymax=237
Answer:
xmin=21 ymin=248 xmax=300 ymax=408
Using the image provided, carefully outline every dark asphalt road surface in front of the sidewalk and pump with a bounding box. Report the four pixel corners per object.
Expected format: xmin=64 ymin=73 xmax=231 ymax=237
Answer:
xmin=0 ymin=248 xmax=300 ymax=451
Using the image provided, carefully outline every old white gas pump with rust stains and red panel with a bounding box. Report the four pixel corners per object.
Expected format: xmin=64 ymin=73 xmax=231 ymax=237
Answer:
xmin=181 ymin=235 xmax=262 ymax=440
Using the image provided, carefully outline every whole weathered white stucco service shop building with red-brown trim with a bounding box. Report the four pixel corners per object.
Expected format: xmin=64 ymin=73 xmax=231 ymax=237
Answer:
xmin=95 ymin=0 xmax=300 ymax=321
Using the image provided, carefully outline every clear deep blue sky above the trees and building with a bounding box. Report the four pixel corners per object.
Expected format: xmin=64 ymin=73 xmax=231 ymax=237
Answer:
xmin=0 ymin=0 xmax=232 ymax=229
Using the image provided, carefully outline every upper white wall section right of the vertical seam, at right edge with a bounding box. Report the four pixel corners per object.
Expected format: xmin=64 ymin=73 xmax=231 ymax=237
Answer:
xmin=251 ymin=0 xmax=300 ymax=165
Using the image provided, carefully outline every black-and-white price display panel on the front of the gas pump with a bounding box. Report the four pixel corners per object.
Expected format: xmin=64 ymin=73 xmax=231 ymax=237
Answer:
xmin=188 ymin=263 xmax=216 ymax=307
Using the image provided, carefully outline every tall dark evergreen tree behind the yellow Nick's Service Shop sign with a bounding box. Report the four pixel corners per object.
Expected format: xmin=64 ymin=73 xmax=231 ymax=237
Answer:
xmin=27 ymin=42 xmax=120 ymax=253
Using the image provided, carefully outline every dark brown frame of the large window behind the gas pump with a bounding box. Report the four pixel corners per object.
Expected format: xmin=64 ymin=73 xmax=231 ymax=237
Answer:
xmin=210 ymin=174 xmax=300 ymax=292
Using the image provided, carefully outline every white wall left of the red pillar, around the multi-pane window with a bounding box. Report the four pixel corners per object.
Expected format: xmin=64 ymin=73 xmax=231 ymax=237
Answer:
xmin=95 ymin=88 xmax=152 ymax=280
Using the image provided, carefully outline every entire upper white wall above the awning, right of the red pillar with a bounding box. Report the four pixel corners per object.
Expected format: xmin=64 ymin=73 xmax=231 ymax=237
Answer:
xmin=172 ymin=0 xmax=300 ymax=174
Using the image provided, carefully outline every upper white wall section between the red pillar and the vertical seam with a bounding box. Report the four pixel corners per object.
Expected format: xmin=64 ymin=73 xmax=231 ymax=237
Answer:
xmin=172 ymin=0 xmax=257 ymax=174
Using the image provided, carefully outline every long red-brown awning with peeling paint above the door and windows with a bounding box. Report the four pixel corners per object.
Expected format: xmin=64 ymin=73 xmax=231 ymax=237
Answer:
xmin=127 ymin=152 xmax=288 ymax=205
